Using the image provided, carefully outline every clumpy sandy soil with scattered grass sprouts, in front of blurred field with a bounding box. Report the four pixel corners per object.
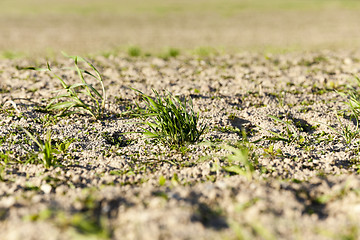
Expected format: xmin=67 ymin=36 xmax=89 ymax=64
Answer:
xmin=0 ymin=52 xmax=360 ymax=240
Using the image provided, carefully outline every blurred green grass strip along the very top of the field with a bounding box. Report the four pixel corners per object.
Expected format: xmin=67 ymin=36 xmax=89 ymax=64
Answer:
xmin=0 ymin=0 xmax=360 ymax=16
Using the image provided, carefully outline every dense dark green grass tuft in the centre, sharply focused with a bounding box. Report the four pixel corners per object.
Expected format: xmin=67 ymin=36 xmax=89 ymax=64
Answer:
xmin=133 ymin=89 xmax=206 ymax=146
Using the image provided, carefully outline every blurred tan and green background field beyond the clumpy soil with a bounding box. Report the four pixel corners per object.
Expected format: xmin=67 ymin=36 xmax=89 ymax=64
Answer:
xmin=0 ymin=0 xmax=360 ymax=58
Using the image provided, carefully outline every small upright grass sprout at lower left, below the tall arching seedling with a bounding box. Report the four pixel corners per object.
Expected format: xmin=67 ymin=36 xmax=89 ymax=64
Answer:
xmin=20 ymin=127 xmax=58 ymax=168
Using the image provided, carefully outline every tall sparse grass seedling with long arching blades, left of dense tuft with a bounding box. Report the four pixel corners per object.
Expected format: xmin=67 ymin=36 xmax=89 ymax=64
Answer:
xmin=26 ymin=54 xmax=106 ymax=119
